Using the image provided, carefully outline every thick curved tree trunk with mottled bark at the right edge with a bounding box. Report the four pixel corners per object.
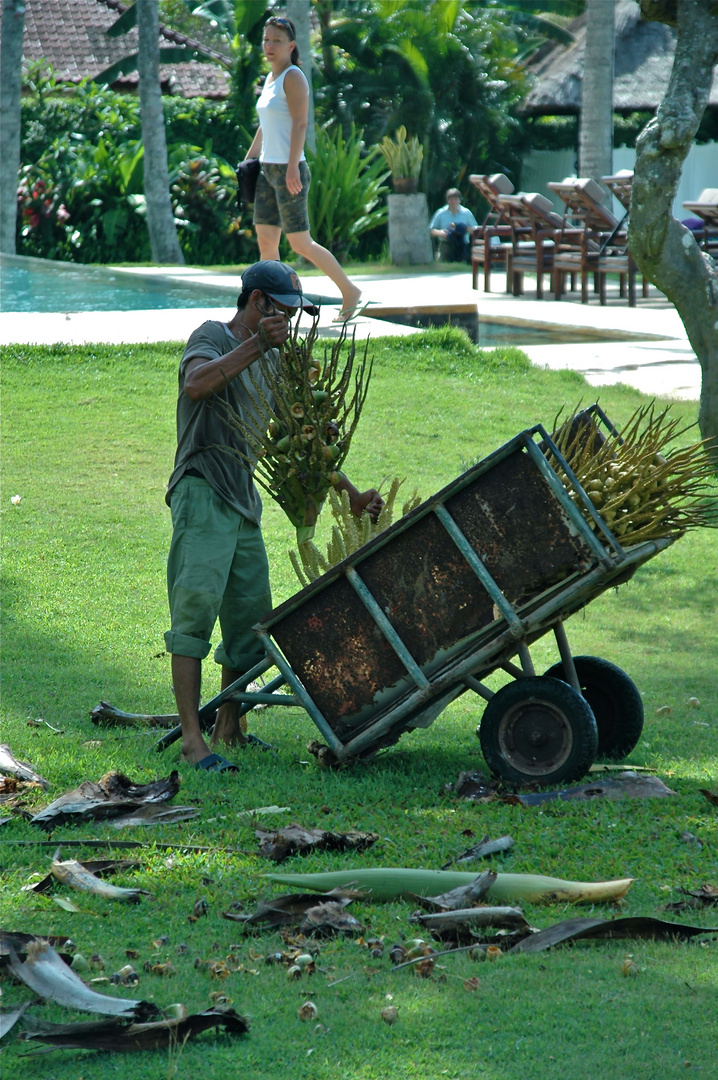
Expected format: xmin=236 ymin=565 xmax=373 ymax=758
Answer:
xmin=628 ymin=0 xmax=718 ymax=463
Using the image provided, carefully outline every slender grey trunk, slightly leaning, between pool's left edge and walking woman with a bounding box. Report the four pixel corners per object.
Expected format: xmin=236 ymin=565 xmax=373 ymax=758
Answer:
xmin=137 ymin=0 xmax=185 ymax=266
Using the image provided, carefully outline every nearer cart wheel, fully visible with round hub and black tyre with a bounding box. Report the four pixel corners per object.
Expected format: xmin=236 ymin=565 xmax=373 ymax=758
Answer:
xmin=478 ymin=676 xmax=598 ymax=784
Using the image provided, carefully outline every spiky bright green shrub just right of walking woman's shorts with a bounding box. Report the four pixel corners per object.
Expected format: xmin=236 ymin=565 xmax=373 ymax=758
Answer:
xmin=307 ymin=124 xmax=389 ymax=258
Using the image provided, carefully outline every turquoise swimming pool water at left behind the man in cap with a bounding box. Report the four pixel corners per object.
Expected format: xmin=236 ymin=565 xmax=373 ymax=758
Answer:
xmin=0 ymin=255 xmax=238 ymax=312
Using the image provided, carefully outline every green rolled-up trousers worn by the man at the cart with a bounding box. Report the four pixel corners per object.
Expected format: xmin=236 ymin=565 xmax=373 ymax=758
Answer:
xmin=164 ymin=476 xmax=272 ymax=673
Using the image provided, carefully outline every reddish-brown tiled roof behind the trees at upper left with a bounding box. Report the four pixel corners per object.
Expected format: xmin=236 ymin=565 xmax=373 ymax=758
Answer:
xmin=23 ymin=0 xmax=230 ymax=98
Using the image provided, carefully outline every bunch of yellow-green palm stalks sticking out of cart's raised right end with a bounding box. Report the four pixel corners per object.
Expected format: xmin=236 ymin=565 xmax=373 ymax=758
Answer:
xmin=553 ymin=402 xmax=718 ymax=546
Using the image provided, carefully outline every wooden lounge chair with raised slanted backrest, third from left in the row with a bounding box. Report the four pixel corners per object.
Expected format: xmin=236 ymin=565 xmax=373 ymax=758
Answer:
xmin=548 ymin=177 xmax=648 ymax=308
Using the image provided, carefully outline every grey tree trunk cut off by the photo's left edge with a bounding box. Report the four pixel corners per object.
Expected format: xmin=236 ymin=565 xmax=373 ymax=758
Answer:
xmin=0 ymin=0 xmax=25 ymax=255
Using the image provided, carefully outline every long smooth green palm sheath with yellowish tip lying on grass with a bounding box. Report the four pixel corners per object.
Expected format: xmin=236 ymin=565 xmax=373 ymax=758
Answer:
xmin=266 ymin=866 xmax=634 ymax=904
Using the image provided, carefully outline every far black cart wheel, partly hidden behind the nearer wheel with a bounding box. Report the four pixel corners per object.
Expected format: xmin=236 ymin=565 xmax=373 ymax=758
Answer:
xmin=544 ymin=657 xmax=644 ymax=761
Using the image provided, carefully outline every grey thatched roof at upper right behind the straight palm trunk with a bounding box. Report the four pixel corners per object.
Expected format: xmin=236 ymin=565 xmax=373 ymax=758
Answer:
xmin=523 ymin=0 xmax=718 ymax=114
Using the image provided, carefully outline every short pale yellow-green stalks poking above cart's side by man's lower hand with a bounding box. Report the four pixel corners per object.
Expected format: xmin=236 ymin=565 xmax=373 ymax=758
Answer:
xmin=289 ymin=476 xmax=421 ymax=586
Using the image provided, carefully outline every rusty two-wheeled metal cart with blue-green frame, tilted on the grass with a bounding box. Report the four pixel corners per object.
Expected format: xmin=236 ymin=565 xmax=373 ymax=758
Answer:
xmin=158 ymin=405 xmax=673 ymax=784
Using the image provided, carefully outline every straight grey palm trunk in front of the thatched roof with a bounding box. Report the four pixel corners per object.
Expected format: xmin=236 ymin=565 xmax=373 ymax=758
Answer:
xmin=579 ymin=0 xmax=615 ymax=180
